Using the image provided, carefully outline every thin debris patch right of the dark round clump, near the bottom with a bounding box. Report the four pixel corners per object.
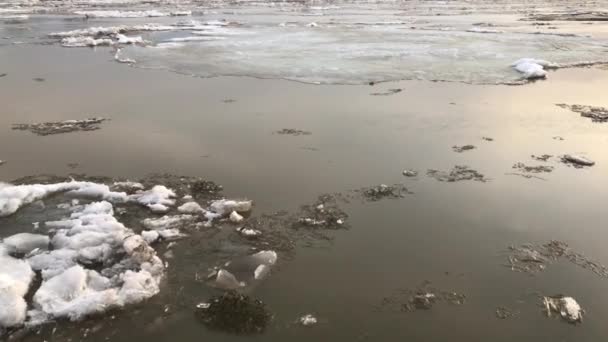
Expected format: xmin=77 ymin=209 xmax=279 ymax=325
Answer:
xmin=380 ymin=281 xmax=466 ymax=312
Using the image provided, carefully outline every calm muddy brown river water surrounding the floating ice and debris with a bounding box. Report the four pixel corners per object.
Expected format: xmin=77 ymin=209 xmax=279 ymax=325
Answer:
xmin=0 ymin=46 xmax=608 ymax=341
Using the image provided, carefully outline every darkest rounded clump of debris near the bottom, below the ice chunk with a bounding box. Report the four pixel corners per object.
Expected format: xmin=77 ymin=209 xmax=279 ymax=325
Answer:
xmin=196 ymin=291 xmax=272 ymax=335
